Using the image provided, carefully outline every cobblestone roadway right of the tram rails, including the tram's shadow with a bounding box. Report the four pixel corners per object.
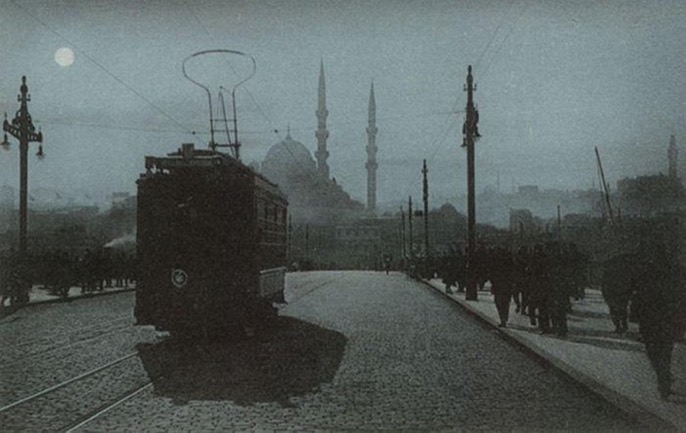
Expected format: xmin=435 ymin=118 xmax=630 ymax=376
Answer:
xmin=0 ymin=272 xmax=652 ymax=432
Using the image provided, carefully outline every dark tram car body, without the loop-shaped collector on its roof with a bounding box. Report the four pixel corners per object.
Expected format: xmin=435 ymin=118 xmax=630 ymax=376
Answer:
xmin=135 ymin=144 xmax=288 ymax=335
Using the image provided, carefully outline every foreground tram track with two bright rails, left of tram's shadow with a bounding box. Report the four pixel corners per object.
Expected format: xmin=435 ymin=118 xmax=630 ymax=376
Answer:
xmin=0 ymin=352 xmax=152 ymax=431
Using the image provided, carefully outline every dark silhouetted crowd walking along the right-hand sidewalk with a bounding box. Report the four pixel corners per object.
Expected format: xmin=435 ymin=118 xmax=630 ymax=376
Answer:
xmin=437 ymin=242 xmax=686 ymax=398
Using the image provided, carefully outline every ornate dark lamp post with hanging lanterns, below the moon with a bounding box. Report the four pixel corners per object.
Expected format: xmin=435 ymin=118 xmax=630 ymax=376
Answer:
xmin=0 ymin=76 xmax=44 ymax=304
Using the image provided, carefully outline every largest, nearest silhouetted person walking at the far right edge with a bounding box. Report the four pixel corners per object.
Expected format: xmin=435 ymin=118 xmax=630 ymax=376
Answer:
xmin=634 ymin=244 xmax=680 ymax=400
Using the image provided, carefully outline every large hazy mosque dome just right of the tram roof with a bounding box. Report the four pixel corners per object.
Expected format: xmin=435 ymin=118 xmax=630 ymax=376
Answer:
xmin=262 ymin=134 xmax=317 ymax=184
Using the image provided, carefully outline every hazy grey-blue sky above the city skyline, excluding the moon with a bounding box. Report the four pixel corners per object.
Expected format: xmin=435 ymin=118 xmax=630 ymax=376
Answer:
xmin=0 ymin=0 xmax=686 ymax=205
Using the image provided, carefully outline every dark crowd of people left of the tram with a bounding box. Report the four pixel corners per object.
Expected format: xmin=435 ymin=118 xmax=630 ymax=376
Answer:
xmin=0 ymin=248 xmax=136 ymax=306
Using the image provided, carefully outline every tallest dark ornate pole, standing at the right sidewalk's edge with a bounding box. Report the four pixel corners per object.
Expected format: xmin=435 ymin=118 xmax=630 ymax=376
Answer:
xmin=462 ymin=65 xmax=481 ymax=301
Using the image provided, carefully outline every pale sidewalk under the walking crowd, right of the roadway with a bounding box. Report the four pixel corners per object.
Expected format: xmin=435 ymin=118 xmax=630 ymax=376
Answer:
xmin=425 ymin=279 xmax=686 ymax=432
